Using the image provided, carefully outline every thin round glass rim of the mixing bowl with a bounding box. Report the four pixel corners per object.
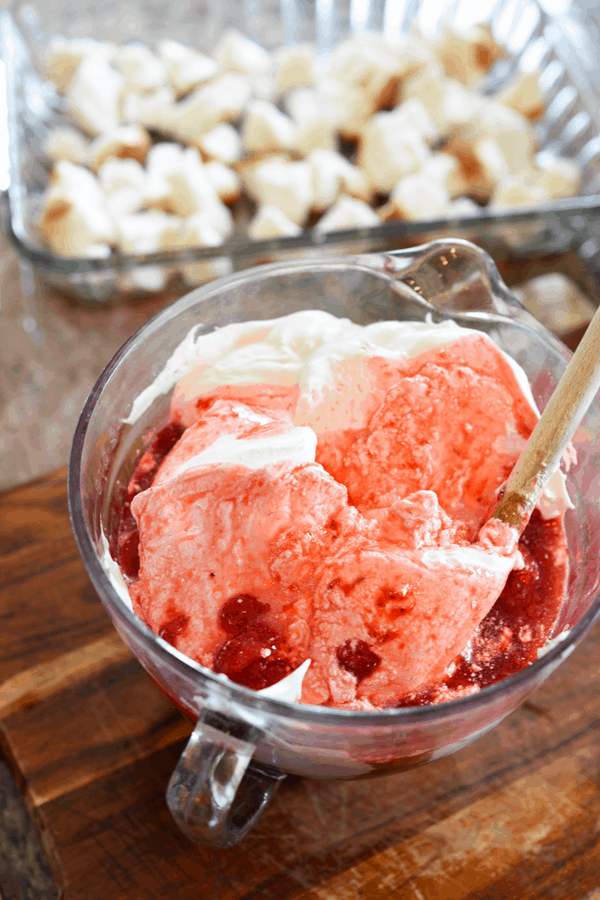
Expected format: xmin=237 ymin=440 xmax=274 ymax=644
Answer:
xmin=67 ymin=250 xmax=600 ymax=727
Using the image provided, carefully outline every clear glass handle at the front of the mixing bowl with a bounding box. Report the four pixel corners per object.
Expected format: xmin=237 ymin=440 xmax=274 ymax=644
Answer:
xmin=166 ymin=710 xmax=286 ymax=847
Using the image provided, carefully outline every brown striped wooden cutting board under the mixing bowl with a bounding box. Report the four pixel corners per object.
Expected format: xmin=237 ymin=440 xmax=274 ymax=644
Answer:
xmin=0 ymin=470 xmax=600 ymax=900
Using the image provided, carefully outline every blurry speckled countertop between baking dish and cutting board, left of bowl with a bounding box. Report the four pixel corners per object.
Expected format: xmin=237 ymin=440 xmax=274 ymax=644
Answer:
xmin=0 ymin=236 xmax=185 ymax=491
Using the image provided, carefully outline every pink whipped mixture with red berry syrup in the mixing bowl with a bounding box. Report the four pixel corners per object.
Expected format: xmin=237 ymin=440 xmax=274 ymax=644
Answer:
xmin=113 ymin=334 xmax=567 ymax=709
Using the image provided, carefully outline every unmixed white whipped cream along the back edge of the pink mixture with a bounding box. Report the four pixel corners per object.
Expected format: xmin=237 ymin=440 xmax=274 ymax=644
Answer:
xmin=123 ymin=310 xmax=574 ymax=518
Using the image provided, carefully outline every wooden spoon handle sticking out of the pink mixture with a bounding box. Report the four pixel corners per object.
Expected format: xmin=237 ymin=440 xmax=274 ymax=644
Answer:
xmin=493 ymin=308 xmax=600 ymax=532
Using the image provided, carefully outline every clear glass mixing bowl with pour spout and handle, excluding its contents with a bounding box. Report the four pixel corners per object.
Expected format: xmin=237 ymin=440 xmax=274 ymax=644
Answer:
xmin=69 ymin=240 xmax=600 ymax=847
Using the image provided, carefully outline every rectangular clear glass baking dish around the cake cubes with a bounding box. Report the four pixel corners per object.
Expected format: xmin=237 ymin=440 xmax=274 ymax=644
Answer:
xmin=0 ymin=0 xmax=600 ymax=303
